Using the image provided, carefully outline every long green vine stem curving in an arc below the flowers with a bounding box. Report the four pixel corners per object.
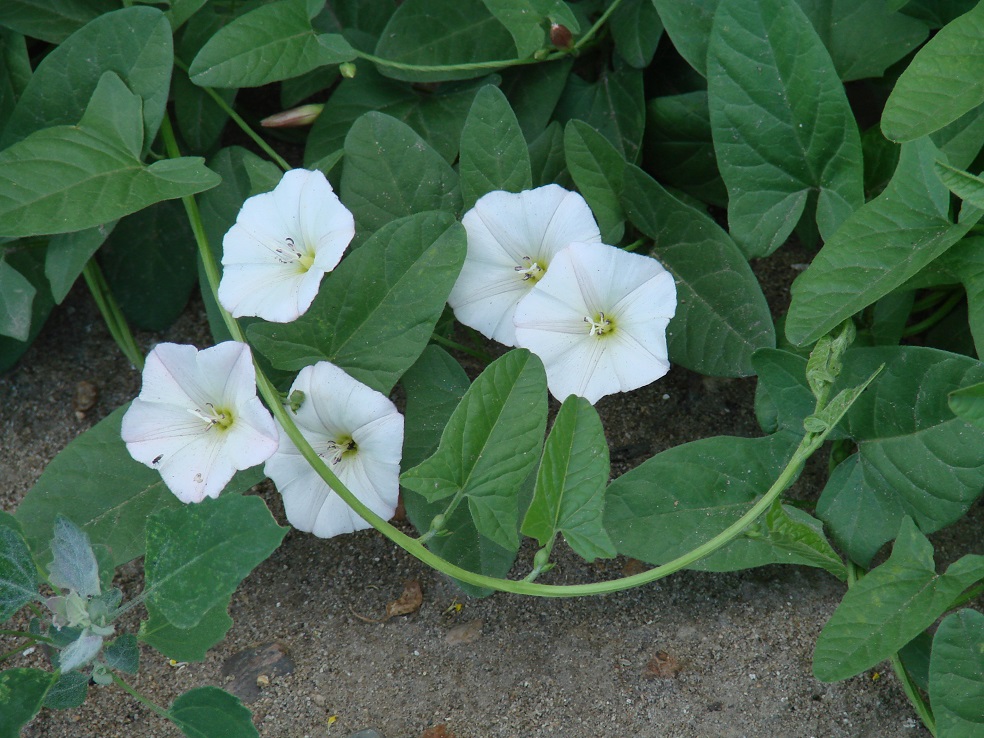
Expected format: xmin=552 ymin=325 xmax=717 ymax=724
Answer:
xmin=161 ymin=116 xmax=870 ymax=597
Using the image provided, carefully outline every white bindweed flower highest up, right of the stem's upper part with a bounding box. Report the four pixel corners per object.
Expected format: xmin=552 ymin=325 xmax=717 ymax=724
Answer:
xmin=219 ymin=169 xmax=355 ymax=323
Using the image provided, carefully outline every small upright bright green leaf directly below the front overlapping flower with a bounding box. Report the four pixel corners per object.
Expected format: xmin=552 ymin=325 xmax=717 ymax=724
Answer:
xmin=522 ymin=395 xmax=615 ymax=561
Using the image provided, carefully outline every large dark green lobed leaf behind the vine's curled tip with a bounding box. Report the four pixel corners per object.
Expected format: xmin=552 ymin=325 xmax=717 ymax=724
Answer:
xmin=817 ymin=346 xmax=984 ymax=565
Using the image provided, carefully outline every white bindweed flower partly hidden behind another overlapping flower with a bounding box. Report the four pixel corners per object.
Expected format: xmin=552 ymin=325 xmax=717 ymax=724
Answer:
xmin=448 ymin=185 xmax=601 ymax=346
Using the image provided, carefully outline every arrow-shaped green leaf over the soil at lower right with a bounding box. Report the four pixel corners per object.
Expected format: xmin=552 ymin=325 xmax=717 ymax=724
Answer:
xmin=813 ymin=518 xmax=984 ymax=690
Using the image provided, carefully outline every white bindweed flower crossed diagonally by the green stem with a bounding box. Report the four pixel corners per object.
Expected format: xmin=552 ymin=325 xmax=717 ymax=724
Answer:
xmin=264 ymin=361 xmax=403 ymax=538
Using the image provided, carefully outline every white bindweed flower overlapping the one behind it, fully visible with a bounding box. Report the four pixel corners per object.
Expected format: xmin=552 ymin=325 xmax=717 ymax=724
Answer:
xmin=516 ymin=243 xmax=676 ymax=404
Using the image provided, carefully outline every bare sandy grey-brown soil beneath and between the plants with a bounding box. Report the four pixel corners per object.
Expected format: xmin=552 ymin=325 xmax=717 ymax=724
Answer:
xmin=0 ymin=243 xmax=984 ymax=738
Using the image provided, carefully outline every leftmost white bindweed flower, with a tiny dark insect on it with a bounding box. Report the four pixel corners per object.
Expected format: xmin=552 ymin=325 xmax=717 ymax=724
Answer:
xmin=120 ymin=341 xmax=277 ymax=502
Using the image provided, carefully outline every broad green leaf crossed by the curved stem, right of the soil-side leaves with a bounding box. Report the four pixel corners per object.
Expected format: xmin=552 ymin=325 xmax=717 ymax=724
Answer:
xmin=605 ymin=433 xmax=815 ymax=571
